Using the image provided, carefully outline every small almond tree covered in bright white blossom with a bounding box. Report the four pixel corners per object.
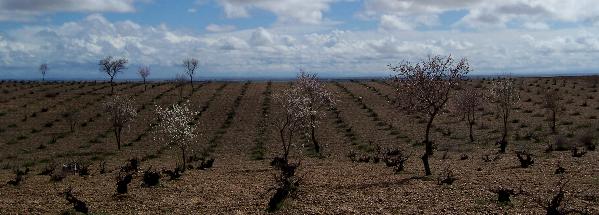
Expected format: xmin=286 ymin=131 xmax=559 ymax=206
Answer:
xmin=154 ymin=101 xmax=197 ymax=167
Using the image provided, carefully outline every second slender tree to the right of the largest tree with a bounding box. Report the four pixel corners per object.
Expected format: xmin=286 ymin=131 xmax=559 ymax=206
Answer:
xmin=489 ymin=77 xmax=520 ymax=153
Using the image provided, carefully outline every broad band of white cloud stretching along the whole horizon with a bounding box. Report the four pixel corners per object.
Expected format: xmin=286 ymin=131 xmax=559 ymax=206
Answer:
xmin=0 ymin=14 xmax=599 ymax=77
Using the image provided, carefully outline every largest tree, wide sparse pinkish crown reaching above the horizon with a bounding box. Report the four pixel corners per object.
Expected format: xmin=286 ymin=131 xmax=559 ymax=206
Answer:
xmin=389 ymin=55 xmax=470 ymax=175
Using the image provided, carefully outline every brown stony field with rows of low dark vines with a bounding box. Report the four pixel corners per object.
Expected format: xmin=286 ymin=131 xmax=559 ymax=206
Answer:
xmin=0 ymin=77 xmax=599 ymax=214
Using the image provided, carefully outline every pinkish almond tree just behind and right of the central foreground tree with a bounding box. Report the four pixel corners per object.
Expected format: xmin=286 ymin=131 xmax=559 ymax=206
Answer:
xmin=293 ymin=70 xmax=336 ymax=153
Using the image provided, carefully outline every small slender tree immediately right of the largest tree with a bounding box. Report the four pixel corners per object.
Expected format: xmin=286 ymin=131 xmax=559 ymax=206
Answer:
xmin=454 ymin=87 xmax=483 ymax=142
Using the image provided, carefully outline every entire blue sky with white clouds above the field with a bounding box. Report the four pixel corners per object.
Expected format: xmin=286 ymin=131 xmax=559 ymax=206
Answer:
xmin=0 ymin=0 xmax=599 ymax=79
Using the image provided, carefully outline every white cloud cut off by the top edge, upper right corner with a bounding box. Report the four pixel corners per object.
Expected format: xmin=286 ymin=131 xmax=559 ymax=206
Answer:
xmin=358 ymin=0 xmax=599 ymax=30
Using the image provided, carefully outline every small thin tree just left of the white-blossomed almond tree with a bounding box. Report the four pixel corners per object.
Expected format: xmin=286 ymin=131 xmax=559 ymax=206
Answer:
xmin=104 ymin=95 xmax=137 ymax=150
